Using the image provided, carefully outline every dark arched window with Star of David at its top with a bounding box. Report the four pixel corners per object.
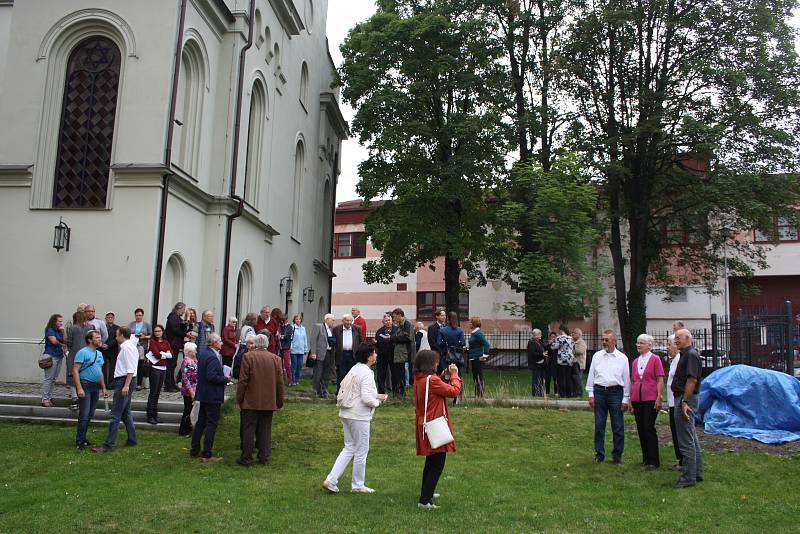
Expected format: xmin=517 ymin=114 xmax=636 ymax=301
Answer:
xmin=53 ymin=36 xmax=121 ymax=208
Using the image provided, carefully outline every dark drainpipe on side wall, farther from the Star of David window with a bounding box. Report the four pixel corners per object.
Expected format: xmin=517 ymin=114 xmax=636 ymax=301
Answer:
xmin=220 ymin=0 xmax=256 ymax=324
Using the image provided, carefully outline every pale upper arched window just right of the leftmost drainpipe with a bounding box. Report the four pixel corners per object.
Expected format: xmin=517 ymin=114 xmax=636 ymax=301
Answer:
xmin=172 ymin=40 xmax=206 ymax=176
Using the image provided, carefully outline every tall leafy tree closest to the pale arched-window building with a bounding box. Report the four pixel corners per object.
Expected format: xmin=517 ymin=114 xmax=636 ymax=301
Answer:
xmin=341 ymin=0 xmax=510 ymax=316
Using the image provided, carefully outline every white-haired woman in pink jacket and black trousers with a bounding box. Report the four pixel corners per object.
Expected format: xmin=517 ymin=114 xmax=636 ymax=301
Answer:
xmin=631 ymin=334 xmax=664 ymax=470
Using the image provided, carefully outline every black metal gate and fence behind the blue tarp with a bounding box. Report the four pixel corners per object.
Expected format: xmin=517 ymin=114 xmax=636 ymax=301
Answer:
xmin=703 ymin=301 xmax=800 ymax=376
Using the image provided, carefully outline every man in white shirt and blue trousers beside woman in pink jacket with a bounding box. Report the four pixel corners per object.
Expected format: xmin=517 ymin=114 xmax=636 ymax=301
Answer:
xmin=586 ymin=330 xmax=631 ymax=464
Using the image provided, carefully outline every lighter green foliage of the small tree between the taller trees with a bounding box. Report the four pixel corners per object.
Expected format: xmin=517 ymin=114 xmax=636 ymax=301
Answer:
xmin=505 ymin=155 xmax=601 ymax=328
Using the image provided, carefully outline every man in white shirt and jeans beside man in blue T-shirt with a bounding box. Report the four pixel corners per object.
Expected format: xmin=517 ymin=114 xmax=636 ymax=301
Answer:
xmin=92 ymin=326 xmax=139 ymax=452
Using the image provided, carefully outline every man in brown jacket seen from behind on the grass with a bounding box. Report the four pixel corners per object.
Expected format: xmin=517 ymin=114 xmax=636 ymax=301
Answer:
xmin=236 ymin=334 xmax=283 ymax=467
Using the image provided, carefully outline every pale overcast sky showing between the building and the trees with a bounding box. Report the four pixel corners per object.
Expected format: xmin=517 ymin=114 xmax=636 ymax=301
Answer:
xmin=327 ymin=0 xmax=800 ymax=202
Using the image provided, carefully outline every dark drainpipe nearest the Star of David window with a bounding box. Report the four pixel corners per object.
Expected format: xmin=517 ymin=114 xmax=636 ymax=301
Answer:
xmin=150 ymin=0 xmax=187 ymax=324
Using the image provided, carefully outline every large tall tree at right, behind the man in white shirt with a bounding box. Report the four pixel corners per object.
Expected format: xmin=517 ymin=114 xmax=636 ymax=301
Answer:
xmin=562 ymin=0 xmax=800 ymax=350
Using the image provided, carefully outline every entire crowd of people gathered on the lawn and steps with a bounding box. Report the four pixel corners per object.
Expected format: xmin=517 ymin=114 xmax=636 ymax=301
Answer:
xmin=40 ymin=302 xmax=703 ymax=509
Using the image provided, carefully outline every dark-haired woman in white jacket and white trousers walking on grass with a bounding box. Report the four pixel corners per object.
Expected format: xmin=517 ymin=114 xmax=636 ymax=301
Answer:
xmin=322 ymin=343 xmax=387 ymax=493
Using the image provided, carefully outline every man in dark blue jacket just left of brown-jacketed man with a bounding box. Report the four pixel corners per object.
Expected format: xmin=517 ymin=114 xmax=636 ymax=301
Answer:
xmin=189 ymin=333 xmax=228 ymax=462
